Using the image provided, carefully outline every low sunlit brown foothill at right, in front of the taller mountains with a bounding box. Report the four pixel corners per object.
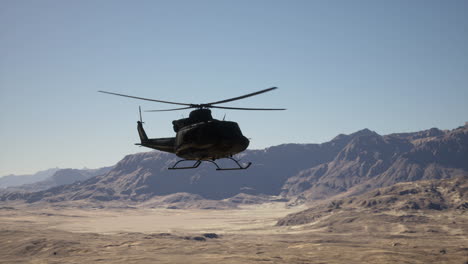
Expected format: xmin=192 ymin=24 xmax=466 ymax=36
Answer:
xmin=277 ymin=176 xmax=468 ymax=226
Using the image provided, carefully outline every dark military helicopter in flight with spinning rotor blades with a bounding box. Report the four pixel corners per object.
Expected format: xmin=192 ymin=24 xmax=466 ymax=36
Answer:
xmin=98 ymin=87 xmax=286 ymax=170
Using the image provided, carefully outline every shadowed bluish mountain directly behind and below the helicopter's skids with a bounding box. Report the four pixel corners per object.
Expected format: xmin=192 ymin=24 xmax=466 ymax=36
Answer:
xmin=8 ymin=139 xmax=349 ymax=202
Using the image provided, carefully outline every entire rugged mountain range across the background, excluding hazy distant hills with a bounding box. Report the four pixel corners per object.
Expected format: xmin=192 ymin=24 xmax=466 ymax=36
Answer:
xmin=0 ymin=127 xmax=468 ymax=202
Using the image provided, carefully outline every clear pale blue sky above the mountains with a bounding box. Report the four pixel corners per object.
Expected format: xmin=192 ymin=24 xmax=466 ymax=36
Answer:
xmin=0 ymin=0 xmax=468 ymax=175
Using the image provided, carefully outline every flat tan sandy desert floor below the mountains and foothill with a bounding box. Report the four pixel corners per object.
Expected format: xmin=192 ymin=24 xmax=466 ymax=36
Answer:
xmin=0 ymin=203 xmax=468 ymax=264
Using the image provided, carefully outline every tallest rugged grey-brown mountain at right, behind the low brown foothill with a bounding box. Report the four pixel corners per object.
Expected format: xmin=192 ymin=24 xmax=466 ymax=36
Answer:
xmin=282 ymin=127 xmax=468 ymax=200
